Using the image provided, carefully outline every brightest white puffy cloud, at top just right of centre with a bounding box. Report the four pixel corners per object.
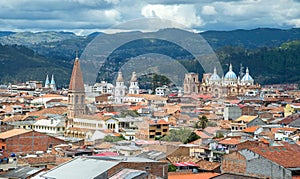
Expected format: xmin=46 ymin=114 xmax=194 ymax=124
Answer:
xmin=141 ymin=4 xmax=203 ymax=27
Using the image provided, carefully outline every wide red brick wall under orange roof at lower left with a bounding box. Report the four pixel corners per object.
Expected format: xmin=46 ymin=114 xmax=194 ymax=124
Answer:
xmin=5 ymin=131 xmax=64 ymax=153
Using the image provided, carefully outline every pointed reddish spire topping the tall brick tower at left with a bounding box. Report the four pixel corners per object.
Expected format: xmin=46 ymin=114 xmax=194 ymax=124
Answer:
xmin=69 ymin=58 xmax=84 ymax=92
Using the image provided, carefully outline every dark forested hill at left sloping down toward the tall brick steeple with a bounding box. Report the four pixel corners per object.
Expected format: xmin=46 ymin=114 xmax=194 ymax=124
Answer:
xmin=0 ymin=45 xmax=71 ymax=85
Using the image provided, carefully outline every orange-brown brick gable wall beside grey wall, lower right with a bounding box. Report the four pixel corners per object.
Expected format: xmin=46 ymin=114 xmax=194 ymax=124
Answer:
xmin=221 ymin=152 xmax=246 ymax=174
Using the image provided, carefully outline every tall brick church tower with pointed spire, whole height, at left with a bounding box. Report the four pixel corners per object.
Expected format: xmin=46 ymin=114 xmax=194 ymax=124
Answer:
xmin=68 ymin=54 xmax=85 ymax=119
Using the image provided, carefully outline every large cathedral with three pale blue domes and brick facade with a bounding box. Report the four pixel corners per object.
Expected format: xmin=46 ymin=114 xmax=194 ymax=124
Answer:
xmin=184 ymin=64 xmax=261 ymax=98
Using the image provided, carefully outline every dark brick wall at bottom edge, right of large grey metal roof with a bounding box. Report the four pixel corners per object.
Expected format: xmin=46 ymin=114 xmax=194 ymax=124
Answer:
xmin=108 ymin=162 xmax=168 ymax=179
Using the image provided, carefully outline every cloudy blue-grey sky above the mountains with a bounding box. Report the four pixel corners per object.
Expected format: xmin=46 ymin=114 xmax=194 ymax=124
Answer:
xmin=0 ymin=0 xmax=300 ymax=34
